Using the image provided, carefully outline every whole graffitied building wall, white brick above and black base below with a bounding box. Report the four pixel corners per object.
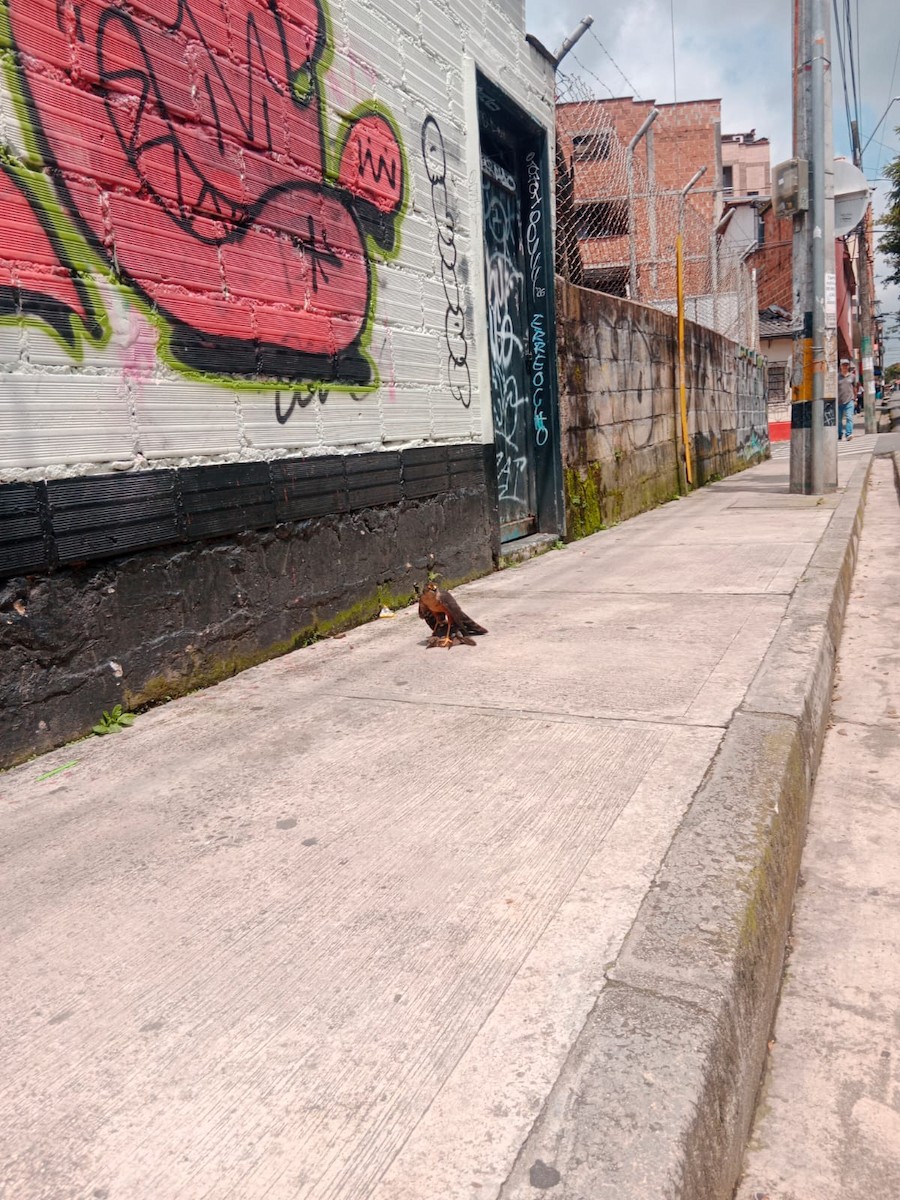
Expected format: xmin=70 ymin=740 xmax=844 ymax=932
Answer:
xmin=0 ymin=0 xmax=553 ymax=766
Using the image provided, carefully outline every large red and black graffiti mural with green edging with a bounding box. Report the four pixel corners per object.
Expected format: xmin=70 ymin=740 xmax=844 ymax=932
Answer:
xmin=0 ymin=0 xmax=408 ymax=389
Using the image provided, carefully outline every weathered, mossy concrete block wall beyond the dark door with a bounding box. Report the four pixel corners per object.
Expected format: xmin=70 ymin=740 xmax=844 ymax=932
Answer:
xmin=557 ymin=278 xmax=768 ymax=538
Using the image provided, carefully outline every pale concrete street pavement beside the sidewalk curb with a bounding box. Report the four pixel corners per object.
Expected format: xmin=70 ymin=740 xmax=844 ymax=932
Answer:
xmin=738 ymin=451 xmax=900 ymax=1200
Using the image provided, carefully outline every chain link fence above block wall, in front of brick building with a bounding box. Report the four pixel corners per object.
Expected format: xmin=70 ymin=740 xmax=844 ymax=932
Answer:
xmin=557 ymin=73 xmax=760 ymax=349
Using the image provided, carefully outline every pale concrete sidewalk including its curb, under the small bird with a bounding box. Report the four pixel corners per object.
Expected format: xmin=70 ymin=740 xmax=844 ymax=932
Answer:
xmin=0 ymin=439 xmax=871 ymax=1200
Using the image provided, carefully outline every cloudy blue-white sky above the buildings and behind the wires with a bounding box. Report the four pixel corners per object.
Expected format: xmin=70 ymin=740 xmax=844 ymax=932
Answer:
xmin=527 ymin=0 xmax=900 ymax=361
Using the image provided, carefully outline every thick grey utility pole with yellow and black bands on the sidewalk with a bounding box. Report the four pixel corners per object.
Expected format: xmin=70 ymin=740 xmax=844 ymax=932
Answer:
xmin=791 ymin=0 xmax=838 ymax=496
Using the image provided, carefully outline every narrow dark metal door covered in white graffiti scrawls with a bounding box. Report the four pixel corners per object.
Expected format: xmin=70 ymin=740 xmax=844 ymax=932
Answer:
xmin=481 ymin=151 xmax=536 ymax=541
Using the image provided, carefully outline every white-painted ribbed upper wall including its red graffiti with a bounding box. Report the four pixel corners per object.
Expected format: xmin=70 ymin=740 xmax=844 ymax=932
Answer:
xmin=0 ymin=0 xmax=552 ymax=477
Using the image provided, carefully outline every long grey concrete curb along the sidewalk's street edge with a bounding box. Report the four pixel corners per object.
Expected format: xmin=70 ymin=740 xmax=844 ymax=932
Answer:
xmin=499 ymin=456 xmax=871 ymax=1200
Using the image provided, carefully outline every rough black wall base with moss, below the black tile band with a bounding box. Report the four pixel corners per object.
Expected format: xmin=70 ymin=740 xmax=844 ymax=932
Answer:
xmin=0 ymin=475 xmax=496 ymax=766
